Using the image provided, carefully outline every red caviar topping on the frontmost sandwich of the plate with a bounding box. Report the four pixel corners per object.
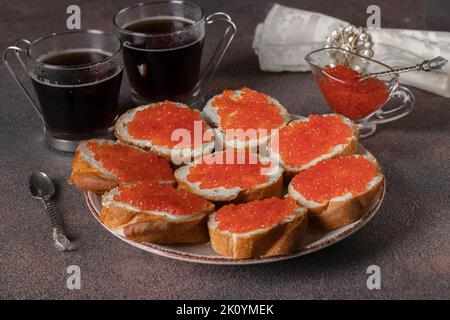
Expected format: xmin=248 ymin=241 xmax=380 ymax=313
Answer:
xmin=216 ymin=198 xmax=297 ymax=233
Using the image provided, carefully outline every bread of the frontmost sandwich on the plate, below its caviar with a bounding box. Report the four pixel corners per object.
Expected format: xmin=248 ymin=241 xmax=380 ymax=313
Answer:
xmin=208 ymin=199 xmax=308 ymax=259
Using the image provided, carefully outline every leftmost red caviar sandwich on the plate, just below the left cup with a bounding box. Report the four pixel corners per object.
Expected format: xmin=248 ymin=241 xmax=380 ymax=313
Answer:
xmin=68 ymin=139 xmax=175 ymax=193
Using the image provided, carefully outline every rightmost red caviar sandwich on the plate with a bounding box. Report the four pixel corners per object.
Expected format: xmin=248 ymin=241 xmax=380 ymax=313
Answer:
xmin=288 ymin=155 xmax=384 ymax=230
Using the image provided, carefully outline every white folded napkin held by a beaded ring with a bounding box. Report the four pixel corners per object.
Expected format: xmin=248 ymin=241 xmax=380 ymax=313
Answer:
xmin=253 ymin=4 xmax=450 ymax=98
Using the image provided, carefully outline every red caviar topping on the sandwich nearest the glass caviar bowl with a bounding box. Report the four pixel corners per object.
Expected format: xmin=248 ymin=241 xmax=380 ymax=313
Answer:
xmin=279 ymin=115 xmax=353 ymax=167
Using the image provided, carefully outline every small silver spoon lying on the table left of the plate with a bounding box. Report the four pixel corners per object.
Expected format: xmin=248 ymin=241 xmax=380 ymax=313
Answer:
xmin=29 ymin=172 xmax=75 ymax=251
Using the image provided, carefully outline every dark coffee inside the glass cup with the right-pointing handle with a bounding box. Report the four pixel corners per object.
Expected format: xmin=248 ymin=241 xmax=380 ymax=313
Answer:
xmin=123 ymin=17 xmax=203 ymax=101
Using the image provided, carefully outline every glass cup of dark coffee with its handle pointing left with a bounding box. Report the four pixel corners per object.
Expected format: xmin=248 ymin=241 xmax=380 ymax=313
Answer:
xmin=3 ymin=30 xmax=123 ymax=151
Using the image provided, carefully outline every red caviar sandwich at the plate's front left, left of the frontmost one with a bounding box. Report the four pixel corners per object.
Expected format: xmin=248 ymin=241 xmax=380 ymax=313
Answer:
xmin=100 ymin=182 xmax=214 ymax=244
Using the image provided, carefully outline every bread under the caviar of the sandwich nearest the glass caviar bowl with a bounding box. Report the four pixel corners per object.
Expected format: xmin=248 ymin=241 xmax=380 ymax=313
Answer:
xmin=269 ymin=114 xmax=359 ymax=177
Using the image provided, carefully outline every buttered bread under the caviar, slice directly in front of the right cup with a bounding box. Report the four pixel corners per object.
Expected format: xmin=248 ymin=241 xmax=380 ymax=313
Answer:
xmin=115 ymin=102 xmax=215 ymax=165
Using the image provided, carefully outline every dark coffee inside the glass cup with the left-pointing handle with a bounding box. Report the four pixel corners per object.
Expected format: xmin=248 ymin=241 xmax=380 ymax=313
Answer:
xmin=32 ymin=50 xmax=122 ymax=136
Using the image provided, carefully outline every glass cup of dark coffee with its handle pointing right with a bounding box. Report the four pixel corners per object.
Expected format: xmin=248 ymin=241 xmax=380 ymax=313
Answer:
xmin=114 ymin=1 xmax=236 ymax=106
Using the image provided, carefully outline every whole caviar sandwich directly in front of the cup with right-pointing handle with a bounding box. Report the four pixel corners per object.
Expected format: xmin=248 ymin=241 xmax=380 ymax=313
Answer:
xmin=116 ymin=101 xmax=214 ymax=164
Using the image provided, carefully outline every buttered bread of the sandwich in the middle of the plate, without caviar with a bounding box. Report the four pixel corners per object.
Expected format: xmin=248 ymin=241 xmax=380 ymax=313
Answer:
xmin=174 ymin=150 xmax=283 ymax=203
